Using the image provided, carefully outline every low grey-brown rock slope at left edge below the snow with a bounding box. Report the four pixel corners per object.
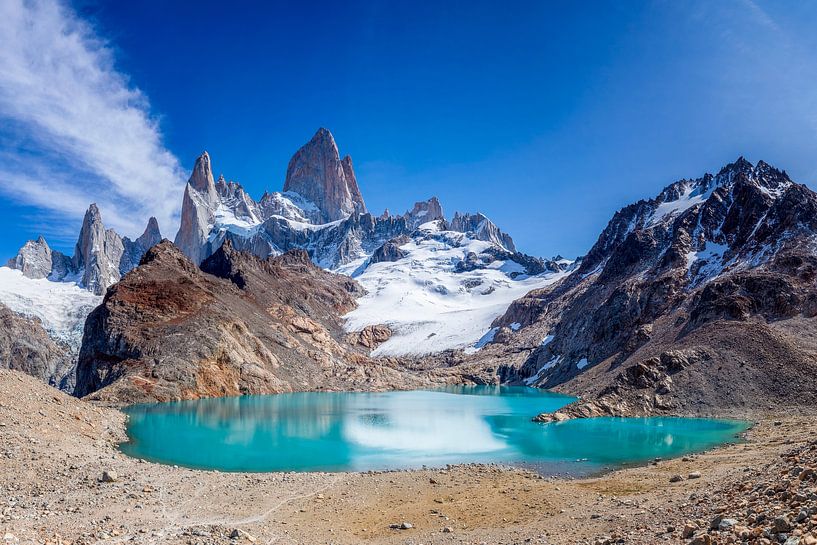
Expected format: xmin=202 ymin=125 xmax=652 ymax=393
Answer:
xmin=0 ymin=304 xmax=74 ymax=391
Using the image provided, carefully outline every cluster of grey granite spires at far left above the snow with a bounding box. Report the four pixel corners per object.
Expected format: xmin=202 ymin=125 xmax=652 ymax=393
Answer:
xmin=8 ymin=204 xmax=162 ymax=295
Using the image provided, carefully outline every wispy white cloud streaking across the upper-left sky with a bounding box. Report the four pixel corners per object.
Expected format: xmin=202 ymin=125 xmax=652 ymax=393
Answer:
xmin=0 ymin=0 xmax=184 ymax=240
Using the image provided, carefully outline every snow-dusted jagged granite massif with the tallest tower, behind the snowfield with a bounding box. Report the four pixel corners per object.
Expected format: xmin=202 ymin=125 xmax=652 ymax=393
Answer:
xmin=175 ymin=128 xmax=543 ymax=274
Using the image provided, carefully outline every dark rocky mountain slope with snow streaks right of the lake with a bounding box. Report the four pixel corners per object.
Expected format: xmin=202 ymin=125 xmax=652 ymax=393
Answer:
xmin=468 ymin=158 xmax=817 ymax=415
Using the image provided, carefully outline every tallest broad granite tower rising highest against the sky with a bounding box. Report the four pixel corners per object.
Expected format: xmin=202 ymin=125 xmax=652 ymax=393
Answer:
xmin=284 ymin=128 xmax=366 ymax=223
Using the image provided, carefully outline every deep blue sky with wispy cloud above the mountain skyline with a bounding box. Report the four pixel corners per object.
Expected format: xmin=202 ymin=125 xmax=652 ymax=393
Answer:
xmin=0 ymin=0 xmax=817 ymax=258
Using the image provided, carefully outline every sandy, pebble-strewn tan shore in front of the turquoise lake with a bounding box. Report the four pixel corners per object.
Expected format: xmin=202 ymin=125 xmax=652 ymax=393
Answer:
xmin=0 ymin=371 xmax=817 ymax=545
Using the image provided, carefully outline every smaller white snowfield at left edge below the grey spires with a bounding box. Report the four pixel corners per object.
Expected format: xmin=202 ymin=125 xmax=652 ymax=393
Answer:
xmin=0 ymin=267 xmax=102 ymax=348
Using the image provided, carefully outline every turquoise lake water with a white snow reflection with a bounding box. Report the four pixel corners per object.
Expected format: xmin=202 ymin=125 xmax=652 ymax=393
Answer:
xmin=121 ymin=386 xmax=747 ymax=473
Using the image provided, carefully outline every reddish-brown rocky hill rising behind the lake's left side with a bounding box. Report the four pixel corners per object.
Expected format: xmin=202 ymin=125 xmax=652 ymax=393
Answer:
xmin=76 ymin=241 xmax=434 ymax=402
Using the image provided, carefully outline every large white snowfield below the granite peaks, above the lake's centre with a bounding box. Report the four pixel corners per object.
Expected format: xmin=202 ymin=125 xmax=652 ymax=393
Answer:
xmin=345 ymin=223 xmax=568 ymax=356
